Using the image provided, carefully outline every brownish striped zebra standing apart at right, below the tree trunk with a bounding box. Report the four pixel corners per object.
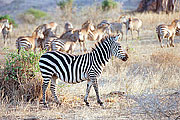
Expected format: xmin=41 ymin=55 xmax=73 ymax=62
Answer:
xmin=156 ymin=19 xmax=180 ymax=48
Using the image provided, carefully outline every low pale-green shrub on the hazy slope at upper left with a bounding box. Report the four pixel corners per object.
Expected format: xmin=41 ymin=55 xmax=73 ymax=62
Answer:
xmin=25 ymin=8 xmax=47 ymax=19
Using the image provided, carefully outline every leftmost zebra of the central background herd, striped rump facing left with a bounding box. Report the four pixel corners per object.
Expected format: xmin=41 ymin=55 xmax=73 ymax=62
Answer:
xmin=16 ymin=29 xmax=42 ymax=54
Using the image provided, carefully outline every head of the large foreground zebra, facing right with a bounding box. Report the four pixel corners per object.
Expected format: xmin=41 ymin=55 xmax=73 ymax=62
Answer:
xmin=111 ymin=35 xmax=128 ymax=61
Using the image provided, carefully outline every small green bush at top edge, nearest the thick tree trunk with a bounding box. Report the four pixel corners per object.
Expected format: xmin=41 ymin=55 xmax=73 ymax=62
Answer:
xmin=102 ymin=0 xmax=117 ymax=11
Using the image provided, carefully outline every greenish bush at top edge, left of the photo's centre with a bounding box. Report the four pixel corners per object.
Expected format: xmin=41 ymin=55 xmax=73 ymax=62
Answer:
xmin=57 ymin=0 xmax=73 ymax=10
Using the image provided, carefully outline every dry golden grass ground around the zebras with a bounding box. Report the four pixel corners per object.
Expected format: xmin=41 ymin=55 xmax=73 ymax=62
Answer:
xmin=0 ymin=8 xmax=180 ymax=120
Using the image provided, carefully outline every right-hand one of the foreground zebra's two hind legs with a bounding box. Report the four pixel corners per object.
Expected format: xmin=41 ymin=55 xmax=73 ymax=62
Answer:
xmin=50 ymin=75 xmax=61 ymax=105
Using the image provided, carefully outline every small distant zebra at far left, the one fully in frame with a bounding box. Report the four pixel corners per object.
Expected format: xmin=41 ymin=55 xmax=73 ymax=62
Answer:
xmin=2 ymin=23 xmax=13 ymax=44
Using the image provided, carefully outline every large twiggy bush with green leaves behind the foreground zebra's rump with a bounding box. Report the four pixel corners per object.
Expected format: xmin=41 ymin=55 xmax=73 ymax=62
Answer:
xmin=0 ymin=50 xmax=42 ymax=101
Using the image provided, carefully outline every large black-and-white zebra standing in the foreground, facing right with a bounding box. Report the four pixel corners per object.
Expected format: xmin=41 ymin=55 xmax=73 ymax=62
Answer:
xmin=39 ymin=35 xmax=128 ymax=106
